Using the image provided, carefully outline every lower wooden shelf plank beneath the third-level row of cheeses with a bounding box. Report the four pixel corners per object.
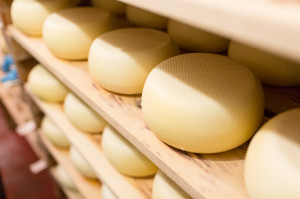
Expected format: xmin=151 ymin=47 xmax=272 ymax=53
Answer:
xmin=39 ymin=132 xmax=101 ymax=199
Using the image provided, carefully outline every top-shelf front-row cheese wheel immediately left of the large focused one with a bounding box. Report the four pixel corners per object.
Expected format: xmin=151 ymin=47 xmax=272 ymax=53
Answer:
xmin=88 ymin=28 xmax=179 ymax=94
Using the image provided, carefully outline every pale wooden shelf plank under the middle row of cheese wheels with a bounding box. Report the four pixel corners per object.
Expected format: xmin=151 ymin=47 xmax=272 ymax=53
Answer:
xmin=26 ymin=86 xmax=153 ymax=199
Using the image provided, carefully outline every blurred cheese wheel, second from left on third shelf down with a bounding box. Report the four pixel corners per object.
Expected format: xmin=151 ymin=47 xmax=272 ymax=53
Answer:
xmin=70 ymin=147 xmax=97 ymax=179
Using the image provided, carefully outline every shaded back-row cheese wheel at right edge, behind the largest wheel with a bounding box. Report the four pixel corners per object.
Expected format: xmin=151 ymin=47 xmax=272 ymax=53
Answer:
xmin=228 ymin=41 xmax=300 ymax=86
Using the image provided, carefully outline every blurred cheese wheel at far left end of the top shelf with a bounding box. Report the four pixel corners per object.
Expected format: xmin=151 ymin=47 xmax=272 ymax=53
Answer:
xmin=11 ymin=0 xmax=74 ymax=36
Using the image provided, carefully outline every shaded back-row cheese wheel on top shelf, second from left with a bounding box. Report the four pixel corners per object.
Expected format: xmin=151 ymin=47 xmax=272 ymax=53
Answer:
xmin=126 ymin=5 xmax=168 ymax=29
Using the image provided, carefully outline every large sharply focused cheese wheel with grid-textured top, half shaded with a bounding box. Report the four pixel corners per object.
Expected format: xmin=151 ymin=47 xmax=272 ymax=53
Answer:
xmin=142 ymin=53 xmax=264 ymax=153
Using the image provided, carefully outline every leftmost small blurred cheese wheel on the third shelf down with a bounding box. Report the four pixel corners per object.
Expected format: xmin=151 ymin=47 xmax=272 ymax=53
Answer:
xmin=41 ymin=116 xmax=70 ymax=148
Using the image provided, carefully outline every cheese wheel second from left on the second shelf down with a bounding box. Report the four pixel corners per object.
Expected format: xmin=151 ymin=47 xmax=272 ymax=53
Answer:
xmin=64 ymin=93 xmax=107 ymax=133
